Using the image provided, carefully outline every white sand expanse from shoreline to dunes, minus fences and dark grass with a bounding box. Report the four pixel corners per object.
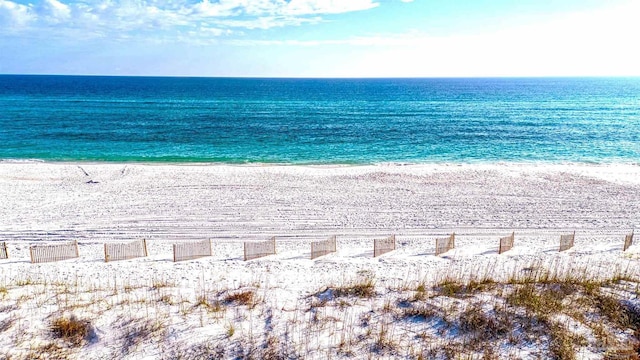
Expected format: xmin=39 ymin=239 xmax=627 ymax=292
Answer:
xmin=0 ymin=162 xmax=640 ymax=359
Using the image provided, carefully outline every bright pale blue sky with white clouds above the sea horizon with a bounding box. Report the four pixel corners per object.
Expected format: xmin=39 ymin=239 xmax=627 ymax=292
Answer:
xmin=0 ymin=0 xmax=640 ymax=77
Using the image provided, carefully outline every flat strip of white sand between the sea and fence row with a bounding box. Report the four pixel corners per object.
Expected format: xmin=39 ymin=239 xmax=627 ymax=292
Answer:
xmin=0 ymin=163 xmax=640 ymax=241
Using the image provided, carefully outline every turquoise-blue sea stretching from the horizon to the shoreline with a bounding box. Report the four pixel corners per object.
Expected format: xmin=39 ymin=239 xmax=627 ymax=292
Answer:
xmin=0 ymin=75 xmax=640 ymax=164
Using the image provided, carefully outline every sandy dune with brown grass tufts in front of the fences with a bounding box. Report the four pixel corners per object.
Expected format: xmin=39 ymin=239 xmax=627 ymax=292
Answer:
xmin=0 ymin=264 xmax=640 ymax=359
